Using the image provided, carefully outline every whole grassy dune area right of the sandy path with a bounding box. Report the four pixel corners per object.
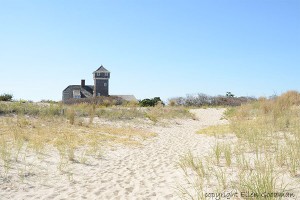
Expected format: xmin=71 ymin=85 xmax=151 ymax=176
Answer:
xmin=180 ymin=91 xmax=300 ymax=199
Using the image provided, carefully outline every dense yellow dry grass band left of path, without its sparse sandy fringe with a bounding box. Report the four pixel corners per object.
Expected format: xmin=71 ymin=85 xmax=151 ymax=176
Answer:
xmin=0 ymin=116 xmax=153 ymax=152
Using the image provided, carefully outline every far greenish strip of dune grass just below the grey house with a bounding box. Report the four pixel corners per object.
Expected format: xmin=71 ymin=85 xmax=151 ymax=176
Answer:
xmin=0 ymin=102 xmax=195 ymax=124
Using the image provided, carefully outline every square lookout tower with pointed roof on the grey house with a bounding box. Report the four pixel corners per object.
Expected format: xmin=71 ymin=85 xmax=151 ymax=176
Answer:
xmin=93 ymin=65 xmax=110 ymax=97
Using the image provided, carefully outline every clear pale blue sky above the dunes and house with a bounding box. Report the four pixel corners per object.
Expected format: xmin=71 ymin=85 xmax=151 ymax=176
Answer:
xmin=0 ymin=0 xmax=300 ymax=101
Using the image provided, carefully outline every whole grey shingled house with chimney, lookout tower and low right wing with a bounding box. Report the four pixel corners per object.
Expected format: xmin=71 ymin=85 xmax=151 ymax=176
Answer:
xmin=62 ymin=65 xmax=136 ymax=102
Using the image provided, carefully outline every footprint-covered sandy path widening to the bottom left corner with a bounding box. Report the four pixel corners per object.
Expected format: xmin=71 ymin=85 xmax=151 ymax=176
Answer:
xmin=0 ymin=109 xmax=227 ymax=199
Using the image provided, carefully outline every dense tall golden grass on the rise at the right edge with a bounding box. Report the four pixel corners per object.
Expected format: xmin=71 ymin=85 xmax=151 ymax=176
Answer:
xmin=231 ymin=91 xmax=300 ymax=176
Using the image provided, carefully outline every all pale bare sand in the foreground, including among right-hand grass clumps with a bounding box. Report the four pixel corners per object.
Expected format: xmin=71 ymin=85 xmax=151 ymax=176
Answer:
xmin=0 ymin=108 xmax=300 ymax=200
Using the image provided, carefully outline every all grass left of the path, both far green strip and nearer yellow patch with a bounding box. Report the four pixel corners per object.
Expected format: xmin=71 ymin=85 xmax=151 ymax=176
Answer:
xmin=0 ymin=101 xmax=193 ymax=182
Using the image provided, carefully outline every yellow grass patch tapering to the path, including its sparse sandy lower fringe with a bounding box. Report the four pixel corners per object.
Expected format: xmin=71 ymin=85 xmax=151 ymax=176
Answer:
xmin=0 ymin=116 xmax=155 ymax=171
